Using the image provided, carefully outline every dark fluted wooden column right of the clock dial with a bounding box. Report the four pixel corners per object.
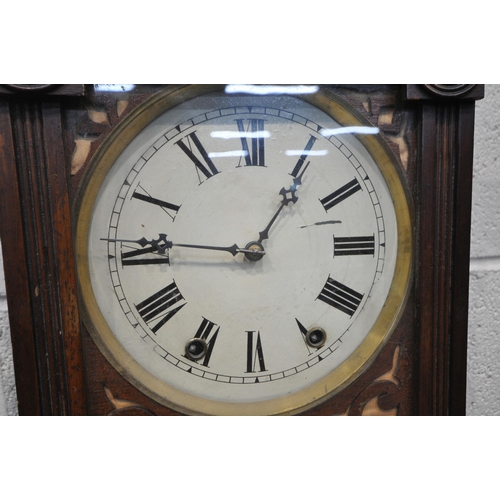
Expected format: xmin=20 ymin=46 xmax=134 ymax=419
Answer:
xmin=407 ymin=85 xmax=484 ymax=415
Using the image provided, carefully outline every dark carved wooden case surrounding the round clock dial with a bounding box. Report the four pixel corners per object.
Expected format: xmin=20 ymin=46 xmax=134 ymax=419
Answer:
xmin=0 ymin=84 xmax=484 ymax=415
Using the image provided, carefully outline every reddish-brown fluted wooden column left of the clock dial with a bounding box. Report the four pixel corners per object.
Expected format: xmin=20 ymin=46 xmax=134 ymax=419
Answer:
xmin=0 ymin=86 xmax=86 ymax=415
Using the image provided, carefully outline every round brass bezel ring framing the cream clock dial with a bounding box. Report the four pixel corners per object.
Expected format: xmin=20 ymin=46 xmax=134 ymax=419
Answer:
xmin=75 ymin=85 xmax=413 ymax=415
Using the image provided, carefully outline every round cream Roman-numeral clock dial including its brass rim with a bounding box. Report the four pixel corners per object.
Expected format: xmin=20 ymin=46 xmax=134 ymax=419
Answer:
xmin=77 ymin=86 xmax=411 ymax=415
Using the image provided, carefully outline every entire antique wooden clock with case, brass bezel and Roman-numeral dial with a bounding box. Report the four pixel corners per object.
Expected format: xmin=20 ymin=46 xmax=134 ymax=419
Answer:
xmin=0 ymin=85 xmax=481 ymax=415
